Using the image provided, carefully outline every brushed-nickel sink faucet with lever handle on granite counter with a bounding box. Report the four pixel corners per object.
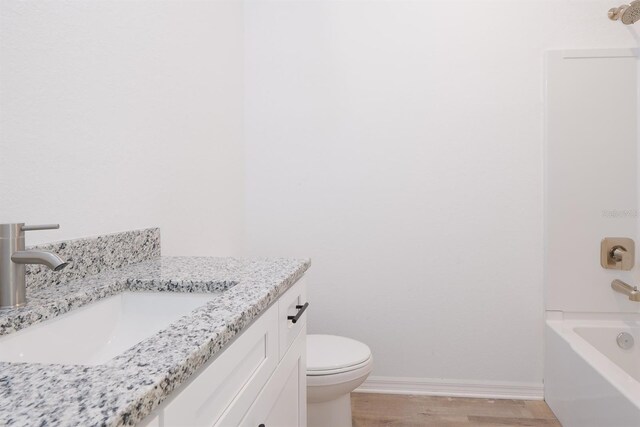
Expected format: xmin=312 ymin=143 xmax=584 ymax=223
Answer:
xmin=0 ymin=223 xmax=68 ymax=309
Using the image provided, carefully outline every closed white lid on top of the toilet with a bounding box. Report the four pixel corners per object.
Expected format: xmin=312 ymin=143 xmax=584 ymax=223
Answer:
xmin=307 ymin=334 xmax=371 ymax=371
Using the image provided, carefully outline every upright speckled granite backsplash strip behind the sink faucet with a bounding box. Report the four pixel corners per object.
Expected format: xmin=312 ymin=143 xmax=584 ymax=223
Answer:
xmin=26 ymin=228 xmax=160 ymax=289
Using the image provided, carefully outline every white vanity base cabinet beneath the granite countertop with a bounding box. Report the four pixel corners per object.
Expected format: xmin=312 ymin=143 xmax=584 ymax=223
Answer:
xmin=139 ymin=279 xmax=307 ymax=427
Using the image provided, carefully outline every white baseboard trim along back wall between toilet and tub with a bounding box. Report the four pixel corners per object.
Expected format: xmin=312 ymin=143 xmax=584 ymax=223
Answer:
xmin=355 ymin=377 xmax=544 ymax=400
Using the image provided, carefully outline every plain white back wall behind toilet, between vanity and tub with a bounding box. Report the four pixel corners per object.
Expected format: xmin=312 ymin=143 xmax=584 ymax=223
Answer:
xmin=245 ymin=0 xmax=638 ymax=390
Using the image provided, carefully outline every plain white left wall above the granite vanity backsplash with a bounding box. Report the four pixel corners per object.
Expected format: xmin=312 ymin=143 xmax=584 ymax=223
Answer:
xmin=0 ymin=0 xmax=244 ymax=255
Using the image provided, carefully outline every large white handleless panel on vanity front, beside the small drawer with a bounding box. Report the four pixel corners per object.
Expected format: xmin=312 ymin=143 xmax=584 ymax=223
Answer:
xmin=161 ymin=304 xmax=279 ymax=427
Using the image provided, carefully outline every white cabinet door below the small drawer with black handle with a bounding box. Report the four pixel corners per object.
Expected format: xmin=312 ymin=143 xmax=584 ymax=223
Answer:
xmin=240 ymin=325 xmax=307 ymax=427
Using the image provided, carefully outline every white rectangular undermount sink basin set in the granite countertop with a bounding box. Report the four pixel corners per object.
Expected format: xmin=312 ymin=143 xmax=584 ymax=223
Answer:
xmin=0 ymin=292 xmax=219 ymax=365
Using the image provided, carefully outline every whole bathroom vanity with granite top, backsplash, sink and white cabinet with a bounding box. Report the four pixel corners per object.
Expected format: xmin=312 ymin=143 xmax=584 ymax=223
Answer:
xmin=0 ymin=229 xmax=310 ymax=427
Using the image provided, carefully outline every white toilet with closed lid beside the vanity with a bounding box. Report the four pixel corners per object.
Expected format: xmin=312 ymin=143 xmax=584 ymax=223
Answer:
xmin=307 ymin=335 xmax=373 ymax=427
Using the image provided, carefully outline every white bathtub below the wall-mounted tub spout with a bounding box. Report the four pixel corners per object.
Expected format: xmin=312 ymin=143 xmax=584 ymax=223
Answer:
xmin=544 ymin=312 xmax=640 ymax=427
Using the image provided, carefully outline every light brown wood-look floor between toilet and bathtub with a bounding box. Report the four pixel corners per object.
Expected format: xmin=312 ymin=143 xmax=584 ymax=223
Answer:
xmin=351 ymin=393 xmax=561 ymax=427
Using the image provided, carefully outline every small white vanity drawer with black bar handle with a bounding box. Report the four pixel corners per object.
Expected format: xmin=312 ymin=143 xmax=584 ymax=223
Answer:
xmin=278 ymin=278 xmax=308 ymax=359
